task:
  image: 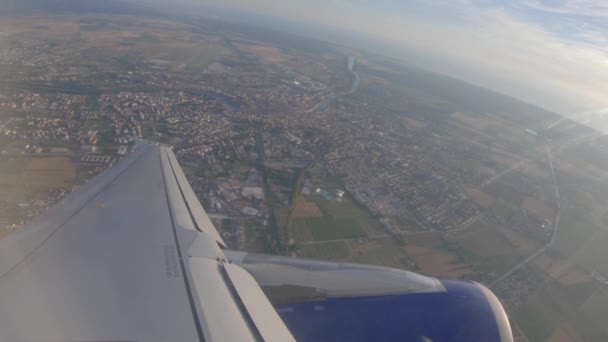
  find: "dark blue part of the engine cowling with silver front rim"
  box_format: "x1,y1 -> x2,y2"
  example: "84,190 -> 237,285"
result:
275,280 -> 513,342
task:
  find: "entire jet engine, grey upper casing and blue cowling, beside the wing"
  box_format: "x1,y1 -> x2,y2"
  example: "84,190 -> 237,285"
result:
226,251 -> 513,342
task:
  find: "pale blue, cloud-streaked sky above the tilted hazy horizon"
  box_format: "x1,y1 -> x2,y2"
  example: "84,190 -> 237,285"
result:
172,0 -> 608,124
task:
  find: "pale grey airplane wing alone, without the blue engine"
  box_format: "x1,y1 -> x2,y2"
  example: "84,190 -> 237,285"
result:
0,144 -> 293,341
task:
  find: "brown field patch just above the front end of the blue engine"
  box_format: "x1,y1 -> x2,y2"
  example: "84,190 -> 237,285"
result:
405,246 -> 473,278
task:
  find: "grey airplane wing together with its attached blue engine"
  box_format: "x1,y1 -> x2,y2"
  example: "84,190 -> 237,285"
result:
0,143 -> 513,341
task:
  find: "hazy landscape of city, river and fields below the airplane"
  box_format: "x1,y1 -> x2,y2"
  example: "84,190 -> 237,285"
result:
0,8 -> 608,341
